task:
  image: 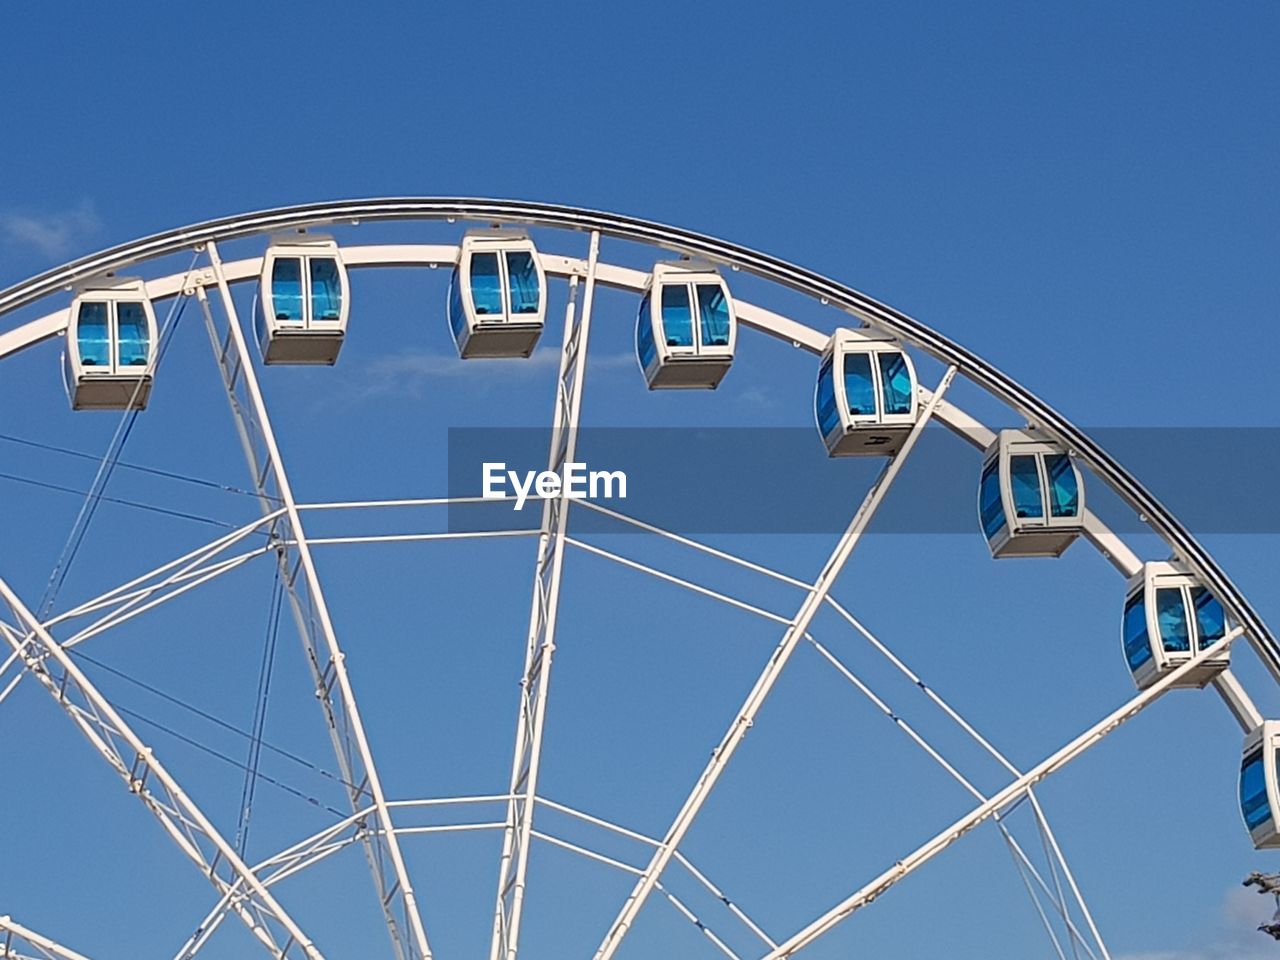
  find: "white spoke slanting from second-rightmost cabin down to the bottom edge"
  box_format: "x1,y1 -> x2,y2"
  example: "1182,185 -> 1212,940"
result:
764,627 -> 1243,960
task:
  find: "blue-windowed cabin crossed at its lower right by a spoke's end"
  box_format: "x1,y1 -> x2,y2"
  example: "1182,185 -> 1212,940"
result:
1121,562 -> 1230,690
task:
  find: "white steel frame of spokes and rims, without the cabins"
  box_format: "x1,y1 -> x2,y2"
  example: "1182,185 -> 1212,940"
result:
0,198 -> 1280,960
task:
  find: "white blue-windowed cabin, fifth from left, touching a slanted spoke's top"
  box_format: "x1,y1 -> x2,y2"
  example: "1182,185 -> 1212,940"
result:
814,328 -> 919,457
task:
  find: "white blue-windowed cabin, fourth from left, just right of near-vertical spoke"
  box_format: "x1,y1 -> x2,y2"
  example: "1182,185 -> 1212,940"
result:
636,261 -> 737,390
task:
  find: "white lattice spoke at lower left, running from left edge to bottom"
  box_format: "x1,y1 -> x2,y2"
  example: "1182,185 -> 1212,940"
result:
0,580 -> 323,960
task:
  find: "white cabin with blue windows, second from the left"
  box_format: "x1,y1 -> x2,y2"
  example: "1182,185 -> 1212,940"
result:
255,237 -> 351,366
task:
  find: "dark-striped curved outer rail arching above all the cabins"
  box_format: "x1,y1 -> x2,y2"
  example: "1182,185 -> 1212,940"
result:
0,197 -> 1280,682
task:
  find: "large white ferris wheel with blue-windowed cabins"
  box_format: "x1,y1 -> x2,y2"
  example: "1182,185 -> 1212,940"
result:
0,197 -> 1280,960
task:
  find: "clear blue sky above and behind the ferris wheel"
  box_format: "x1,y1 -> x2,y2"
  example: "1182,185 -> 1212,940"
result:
0,3 -> 1280,960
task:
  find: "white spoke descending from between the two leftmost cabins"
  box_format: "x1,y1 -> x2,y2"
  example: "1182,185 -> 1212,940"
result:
195,241 -> 431,960
